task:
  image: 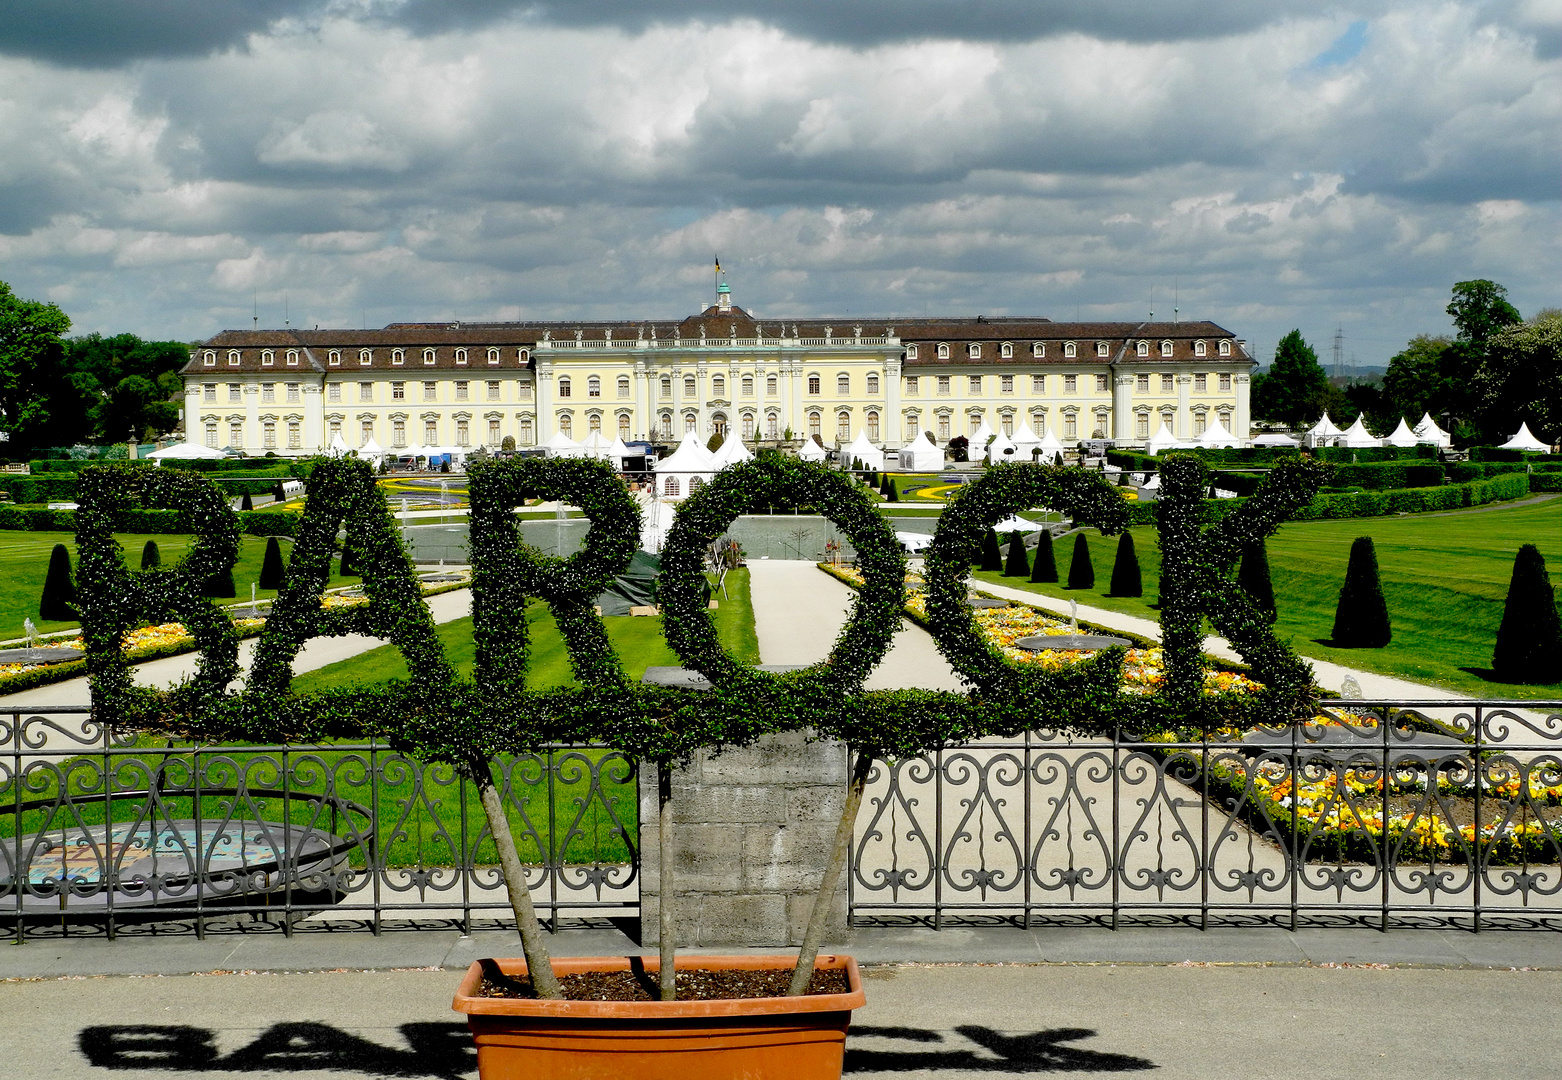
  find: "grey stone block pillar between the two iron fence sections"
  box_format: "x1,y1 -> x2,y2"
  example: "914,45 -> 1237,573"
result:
640,733 -> 848,946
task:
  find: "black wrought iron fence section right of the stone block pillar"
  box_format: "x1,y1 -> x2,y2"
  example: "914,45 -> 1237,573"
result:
848,700 -> 1562,930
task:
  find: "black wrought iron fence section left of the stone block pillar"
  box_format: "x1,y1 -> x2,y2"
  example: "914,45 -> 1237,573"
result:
0,706 -> 639,941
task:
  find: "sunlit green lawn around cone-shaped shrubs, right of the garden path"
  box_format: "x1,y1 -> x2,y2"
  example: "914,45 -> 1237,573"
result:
973,499 -> 1562,699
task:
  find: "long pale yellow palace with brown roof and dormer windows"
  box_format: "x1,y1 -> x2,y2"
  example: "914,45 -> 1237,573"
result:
183,283 -> 1254,456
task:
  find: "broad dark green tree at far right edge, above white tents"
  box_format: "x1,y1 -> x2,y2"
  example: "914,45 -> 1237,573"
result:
1473,308 -> 1562,442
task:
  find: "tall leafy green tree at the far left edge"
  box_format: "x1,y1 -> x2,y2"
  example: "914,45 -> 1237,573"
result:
0,281 -> 73,453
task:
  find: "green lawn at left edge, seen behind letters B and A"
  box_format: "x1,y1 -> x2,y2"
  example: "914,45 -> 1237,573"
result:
0,530 -> 358,639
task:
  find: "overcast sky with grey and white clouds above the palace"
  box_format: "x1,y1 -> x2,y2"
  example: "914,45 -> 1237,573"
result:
0,0 -> 1562,364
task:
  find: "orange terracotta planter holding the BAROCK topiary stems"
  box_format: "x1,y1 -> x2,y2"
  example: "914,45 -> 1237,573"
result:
453,957 -> 867,1080
